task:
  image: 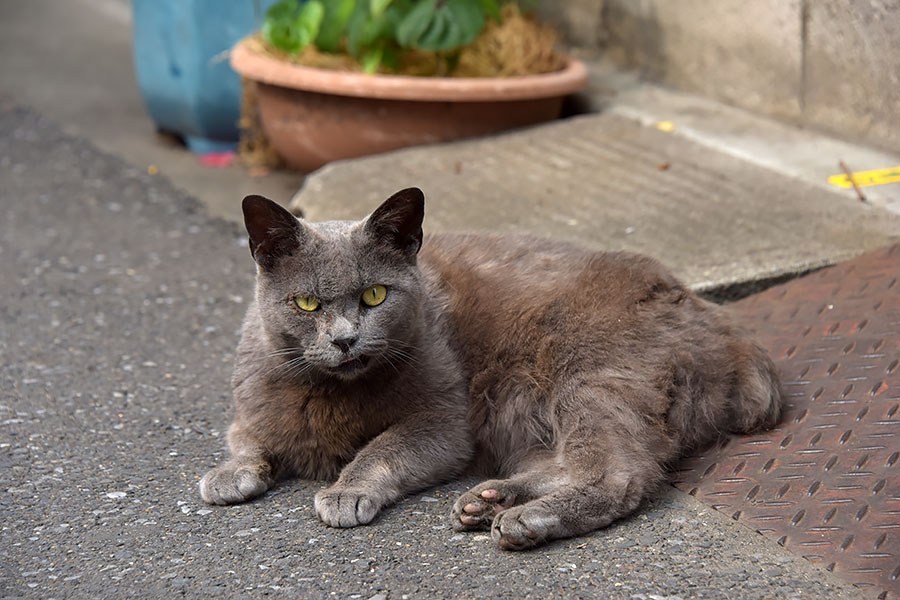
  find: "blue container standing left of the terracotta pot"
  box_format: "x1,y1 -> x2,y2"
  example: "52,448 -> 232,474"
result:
132,0 -> 275,153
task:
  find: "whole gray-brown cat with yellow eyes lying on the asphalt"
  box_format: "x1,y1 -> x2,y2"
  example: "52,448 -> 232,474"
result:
200,188 -> 782,550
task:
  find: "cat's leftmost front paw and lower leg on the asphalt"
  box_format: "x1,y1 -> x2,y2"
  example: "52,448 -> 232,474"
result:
200,425 -> 275,504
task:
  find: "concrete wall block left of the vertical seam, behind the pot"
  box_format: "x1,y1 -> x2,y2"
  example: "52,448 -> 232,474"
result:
605,0 -> 802,120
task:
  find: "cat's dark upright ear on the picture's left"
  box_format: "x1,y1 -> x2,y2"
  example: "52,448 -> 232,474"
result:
241,195 -> 303,269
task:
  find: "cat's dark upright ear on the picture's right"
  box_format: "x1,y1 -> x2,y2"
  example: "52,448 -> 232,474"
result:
366,188 -> 425,256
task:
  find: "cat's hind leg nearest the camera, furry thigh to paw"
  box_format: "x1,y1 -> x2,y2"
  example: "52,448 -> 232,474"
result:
491,420 -> 667,550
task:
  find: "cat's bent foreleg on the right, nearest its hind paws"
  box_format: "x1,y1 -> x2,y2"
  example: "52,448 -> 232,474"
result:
315,414 -> 472,527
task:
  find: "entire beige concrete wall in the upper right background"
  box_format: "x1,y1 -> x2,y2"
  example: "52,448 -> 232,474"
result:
541,0 -> 900,152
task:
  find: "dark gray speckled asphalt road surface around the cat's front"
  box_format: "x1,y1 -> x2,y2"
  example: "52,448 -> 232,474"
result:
0,102 -> 859,600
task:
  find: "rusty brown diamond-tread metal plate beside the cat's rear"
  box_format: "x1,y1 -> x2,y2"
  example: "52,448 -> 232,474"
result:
675,244 -> 900,598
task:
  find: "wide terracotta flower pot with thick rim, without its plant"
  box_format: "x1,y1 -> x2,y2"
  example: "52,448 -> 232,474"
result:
231,42 -> 587,171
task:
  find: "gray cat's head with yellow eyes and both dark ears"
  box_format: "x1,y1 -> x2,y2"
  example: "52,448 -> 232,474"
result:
243,188 -> 425,381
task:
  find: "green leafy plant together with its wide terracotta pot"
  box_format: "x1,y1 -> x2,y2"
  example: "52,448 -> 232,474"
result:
231,0 -> 587,171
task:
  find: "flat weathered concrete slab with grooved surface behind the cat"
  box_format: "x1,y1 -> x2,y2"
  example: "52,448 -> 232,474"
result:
292,109 -> 900,291
